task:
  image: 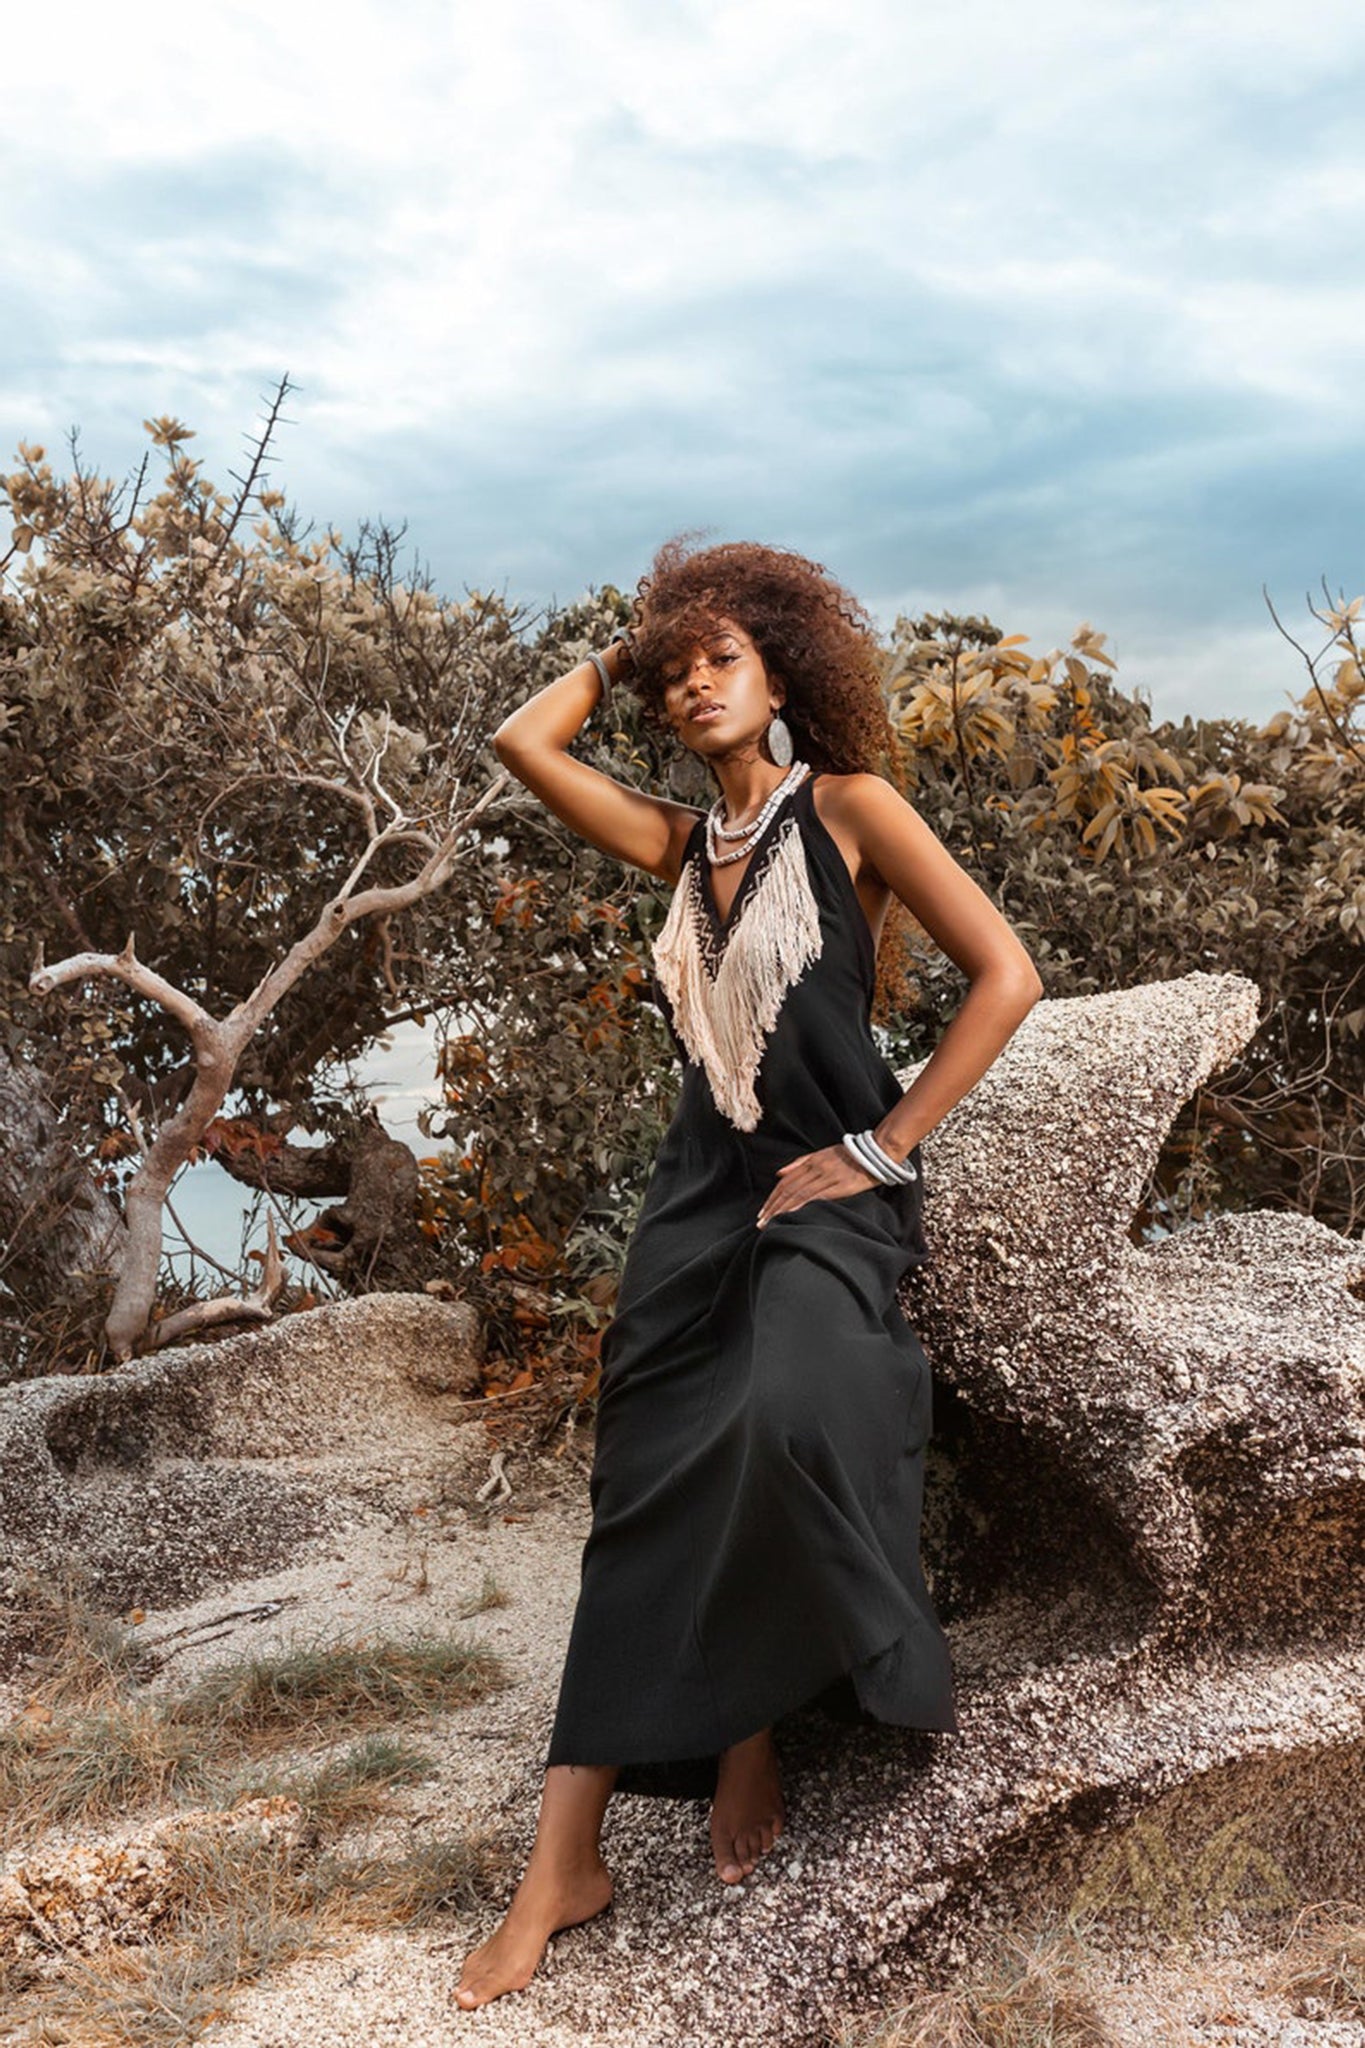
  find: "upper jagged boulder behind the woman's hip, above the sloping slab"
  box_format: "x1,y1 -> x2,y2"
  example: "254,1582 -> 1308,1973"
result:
902,975 -> 1365,1638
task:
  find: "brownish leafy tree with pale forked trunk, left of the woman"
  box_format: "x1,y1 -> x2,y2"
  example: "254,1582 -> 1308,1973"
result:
0,385 -> 526,1358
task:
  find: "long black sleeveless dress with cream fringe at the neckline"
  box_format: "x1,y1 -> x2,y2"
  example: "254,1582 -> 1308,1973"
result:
546,776 -> 958,1794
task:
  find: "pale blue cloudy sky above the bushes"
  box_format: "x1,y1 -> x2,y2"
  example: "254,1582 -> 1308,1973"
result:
0,0 -> 1365,717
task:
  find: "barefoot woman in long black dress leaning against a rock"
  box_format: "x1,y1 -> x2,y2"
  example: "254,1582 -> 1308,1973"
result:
454,543 -> 1042,2009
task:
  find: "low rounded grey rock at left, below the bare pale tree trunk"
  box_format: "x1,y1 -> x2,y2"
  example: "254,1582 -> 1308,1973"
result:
0,1294 -> 479,1613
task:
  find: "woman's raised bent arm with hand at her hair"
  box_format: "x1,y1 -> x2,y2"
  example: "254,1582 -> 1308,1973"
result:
493,641 -> 702,883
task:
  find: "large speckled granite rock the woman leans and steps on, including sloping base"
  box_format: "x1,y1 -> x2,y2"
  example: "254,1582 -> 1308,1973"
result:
464,975 -> 1365,2048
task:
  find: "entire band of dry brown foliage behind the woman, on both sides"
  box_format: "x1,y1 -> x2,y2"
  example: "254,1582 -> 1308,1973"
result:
0,406 -> 1365,1392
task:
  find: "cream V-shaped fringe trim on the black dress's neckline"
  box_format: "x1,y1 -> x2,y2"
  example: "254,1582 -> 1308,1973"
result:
651,817 -> 821,1130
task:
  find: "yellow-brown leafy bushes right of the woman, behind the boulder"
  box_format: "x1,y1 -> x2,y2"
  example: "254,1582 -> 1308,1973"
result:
886,598 -> 1365,1233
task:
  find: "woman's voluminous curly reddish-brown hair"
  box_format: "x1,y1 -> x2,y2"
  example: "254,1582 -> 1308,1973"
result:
630,535 -> 902,784
